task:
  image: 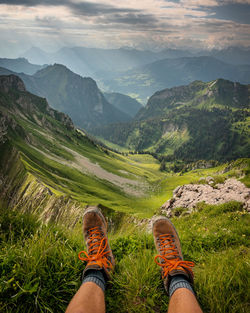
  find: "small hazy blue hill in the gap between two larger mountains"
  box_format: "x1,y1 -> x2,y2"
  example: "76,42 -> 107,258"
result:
103,92 -> 142,117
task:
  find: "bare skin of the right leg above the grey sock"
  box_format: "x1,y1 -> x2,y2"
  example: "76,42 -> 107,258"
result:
168,288 -> 202,313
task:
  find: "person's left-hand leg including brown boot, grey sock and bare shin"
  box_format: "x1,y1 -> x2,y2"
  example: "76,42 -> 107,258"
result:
66,207 -> 115,313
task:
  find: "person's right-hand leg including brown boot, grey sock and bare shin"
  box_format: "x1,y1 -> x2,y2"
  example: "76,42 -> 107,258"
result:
152,217 -> 202,313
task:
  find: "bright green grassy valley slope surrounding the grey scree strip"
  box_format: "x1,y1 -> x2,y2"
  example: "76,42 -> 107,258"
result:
6,100 -> 234,217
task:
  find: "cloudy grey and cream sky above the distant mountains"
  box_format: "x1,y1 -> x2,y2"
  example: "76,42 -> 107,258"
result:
0,0 -> 250,57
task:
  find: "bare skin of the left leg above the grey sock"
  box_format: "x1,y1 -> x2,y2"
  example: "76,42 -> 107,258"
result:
65,282 -> 105,313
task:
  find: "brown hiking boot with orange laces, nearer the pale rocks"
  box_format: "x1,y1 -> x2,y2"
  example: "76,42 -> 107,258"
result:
152,216 -> 194,292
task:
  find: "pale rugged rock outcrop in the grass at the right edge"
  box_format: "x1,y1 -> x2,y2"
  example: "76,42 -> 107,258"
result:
161,177 -> 250,217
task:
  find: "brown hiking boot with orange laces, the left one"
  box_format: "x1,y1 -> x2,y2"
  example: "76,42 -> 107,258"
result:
78,207 -> 115,280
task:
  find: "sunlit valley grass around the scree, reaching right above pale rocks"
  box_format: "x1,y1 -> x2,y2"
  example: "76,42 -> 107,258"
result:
4,134 -> 249,218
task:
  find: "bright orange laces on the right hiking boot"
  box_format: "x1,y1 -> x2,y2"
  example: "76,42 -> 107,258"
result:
155,234 -> 194,278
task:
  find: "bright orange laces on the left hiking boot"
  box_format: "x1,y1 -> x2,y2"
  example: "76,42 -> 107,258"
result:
78,227 -> 112,269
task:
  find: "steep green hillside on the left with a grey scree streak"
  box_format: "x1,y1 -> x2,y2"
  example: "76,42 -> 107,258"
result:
0,75 -> 173,221
